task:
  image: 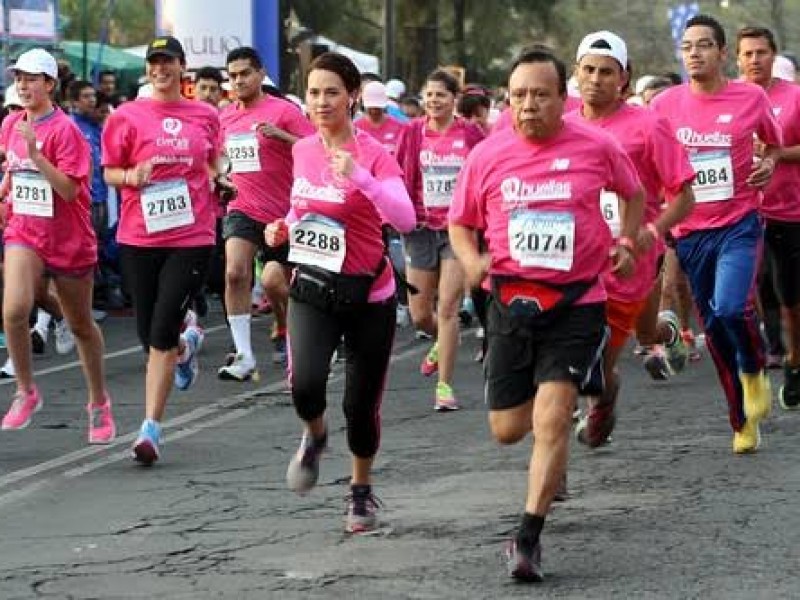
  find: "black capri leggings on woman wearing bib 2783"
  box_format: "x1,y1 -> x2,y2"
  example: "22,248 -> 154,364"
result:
120,246 -> 214,351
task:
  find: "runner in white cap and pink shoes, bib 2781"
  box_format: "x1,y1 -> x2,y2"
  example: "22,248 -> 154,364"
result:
0,48 -> 116,444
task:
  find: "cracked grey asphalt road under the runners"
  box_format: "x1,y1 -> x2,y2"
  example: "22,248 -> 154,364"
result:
0,308 -> 800,600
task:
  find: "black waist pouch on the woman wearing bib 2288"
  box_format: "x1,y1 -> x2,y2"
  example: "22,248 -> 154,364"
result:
289,265 -> 377,312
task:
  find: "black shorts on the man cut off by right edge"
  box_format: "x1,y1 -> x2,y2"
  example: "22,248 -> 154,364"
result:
764,219 -> 800,307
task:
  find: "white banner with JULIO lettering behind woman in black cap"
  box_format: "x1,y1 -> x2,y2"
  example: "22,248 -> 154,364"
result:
156,0 -> 253,69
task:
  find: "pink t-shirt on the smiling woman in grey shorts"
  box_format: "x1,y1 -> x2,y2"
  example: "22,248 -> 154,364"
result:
409,119 -> 472,231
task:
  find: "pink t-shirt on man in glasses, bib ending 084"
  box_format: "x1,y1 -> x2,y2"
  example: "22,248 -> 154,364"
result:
650,81 -> 781,237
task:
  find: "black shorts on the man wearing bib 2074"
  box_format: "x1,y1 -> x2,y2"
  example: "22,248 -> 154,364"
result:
484,298 -> 606,410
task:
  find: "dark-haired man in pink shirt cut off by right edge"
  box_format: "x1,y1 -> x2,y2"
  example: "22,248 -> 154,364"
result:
736,27 -> 800,410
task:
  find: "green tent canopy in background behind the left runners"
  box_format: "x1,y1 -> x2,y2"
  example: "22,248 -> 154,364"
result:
56,41 -> 144,95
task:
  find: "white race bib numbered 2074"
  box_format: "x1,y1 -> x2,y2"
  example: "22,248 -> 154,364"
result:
508,210 -> 575,271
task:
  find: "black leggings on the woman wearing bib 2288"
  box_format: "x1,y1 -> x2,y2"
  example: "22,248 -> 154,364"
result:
287,298 -> 396,458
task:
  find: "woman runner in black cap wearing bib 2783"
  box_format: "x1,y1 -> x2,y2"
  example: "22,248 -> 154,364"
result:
103,37 -> 219,465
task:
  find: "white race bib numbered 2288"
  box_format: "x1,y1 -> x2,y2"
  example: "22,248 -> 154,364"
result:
289,214 -> 347,273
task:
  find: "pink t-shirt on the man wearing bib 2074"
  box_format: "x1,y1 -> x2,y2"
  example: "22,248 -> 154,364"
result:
450,121 -> 640,304
